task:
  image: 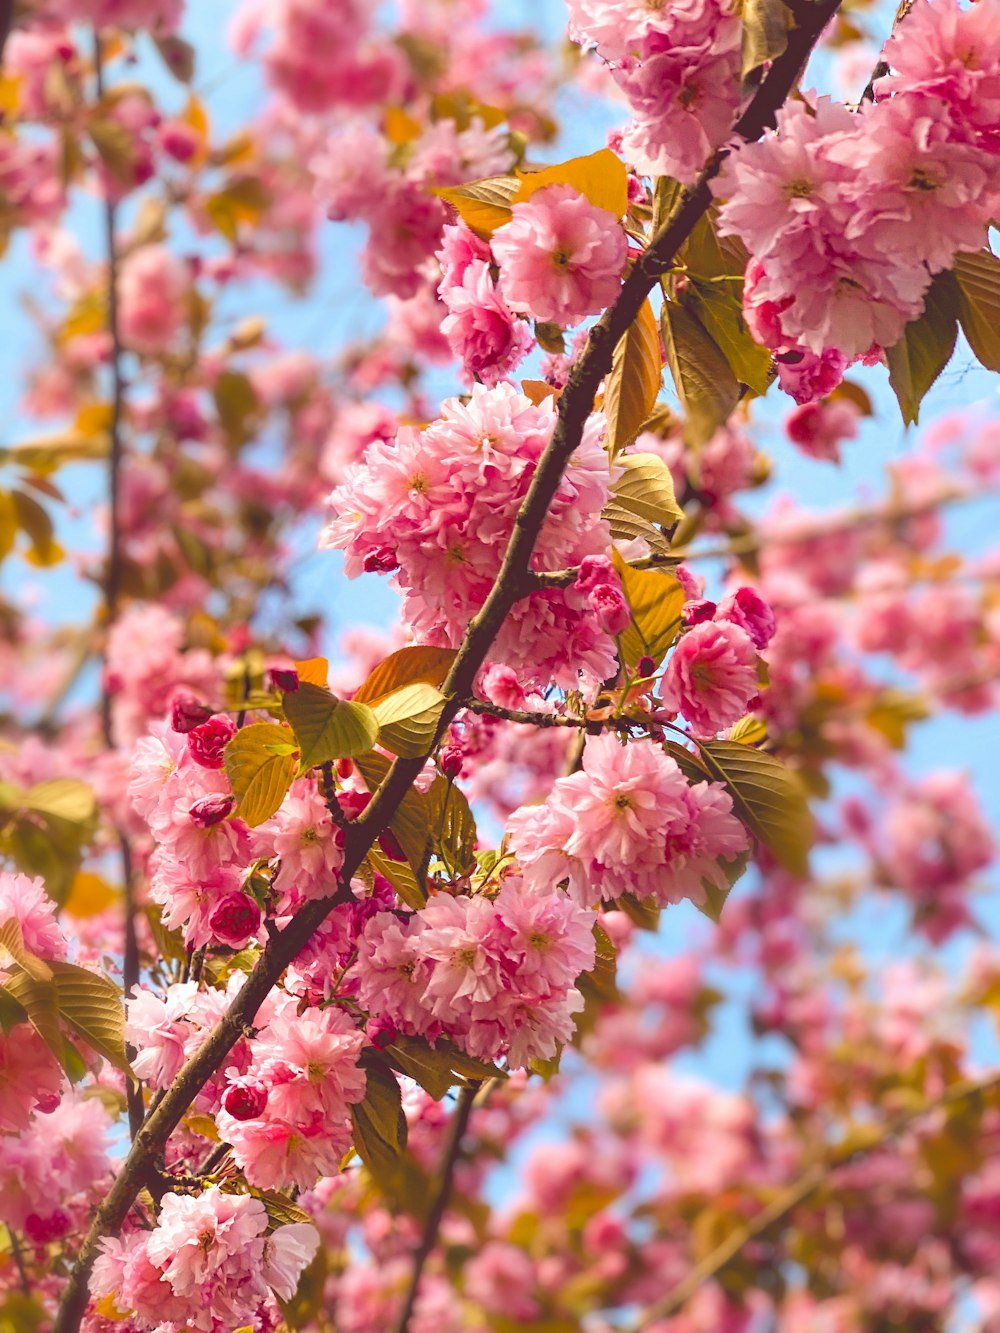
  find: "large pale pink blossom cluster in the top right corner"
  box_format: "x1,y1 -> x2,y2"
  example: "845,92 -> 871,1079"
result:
713,0 -> 1000,381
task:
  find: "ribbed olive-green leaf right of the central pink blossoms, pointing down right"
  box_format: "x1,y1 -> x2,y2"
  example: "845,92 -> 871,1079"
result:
699,741 -> 813,877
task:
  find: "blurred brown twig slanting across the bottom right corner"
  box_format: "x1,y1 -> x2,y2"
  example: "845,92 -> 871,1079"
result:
627,1072 -> 1000,1333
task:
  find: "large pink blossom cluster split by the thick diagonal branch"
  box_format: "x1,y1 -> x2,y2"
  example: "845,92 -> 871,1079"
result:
323,383 -> 615,688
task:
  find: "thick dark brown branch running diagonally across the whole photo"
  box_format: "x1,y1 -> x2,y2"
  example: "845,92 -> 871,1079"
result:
53,0 -> 840,1333
